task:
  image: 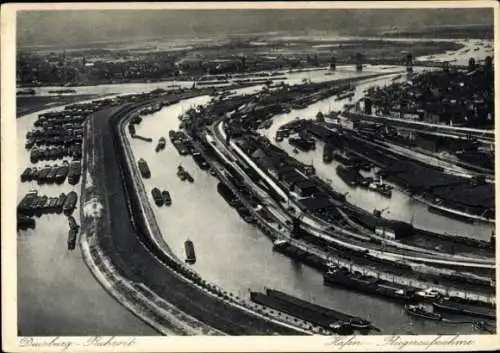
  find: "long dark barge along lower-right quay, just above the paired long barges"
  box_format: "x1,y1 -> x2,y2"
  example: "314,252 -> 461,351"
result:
323,267 -> 414,302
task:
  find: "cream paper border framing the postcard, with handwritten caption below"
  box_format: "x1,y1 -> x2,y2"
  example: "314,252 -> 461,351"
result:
0,1 -> 500,352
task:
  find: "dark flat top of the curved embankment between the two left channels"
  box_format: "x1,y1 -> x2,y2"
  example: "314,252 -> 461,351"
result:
85,97 -> 297,335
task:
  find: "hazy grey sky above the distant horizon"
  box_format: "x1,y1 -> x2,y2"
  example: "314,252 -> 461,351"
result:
17,9 -> 493,47
